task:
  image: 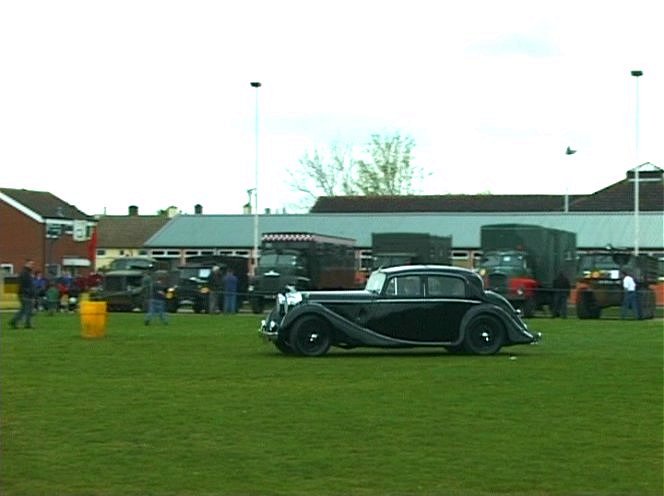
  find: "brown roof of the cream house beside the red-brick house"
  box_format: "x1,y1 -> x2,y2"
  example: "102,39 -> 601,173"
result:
97,215 -> 170,248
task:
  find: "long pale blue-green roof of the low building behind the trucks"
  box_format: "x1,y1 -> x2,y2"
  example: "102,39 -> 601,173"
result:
148,212 -> 664,254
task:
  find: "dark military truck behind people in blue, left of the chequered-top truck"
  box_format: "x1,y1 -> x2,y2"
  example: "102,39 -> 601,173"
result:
166,255 -> 249,313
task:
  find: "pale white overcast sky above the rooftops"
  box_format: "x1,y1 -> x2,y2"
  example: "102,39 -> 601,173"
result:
0,0 -> 664,215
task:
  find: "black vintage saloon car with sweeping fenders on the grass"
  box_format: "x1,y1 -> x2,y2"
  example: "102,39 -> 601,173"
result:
260,265 -> 540,356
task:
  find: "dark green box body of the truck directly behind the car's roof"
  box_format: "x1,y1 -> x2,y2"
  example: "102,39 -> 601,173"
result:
371,232 -> 452,269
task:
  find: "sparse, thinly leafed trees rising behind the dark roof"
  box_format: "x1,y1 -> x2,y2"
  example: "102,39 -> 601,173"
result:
291,133 -> 422,207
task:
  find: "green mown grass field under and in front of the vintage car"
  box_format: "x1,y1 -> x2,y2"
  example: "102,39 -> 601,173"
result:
0,313 -> 664,496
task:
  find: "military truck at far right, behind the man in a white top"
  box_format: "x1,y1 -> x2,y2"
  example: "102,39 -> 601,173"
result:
575,248 -> 659,319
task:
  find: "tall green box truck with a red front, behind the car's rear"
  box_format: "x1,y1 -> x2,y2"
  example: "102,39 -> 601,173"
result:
479,224 -> 576,317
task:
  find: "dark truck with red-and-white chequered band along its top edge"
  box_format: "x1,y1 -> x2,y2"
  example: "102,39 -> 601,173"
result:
249,232 -> 355,313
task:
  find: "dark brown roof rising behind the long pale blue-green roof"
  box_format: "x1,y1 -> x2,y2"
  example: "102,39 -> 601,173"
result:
311,162 -> 664,213
